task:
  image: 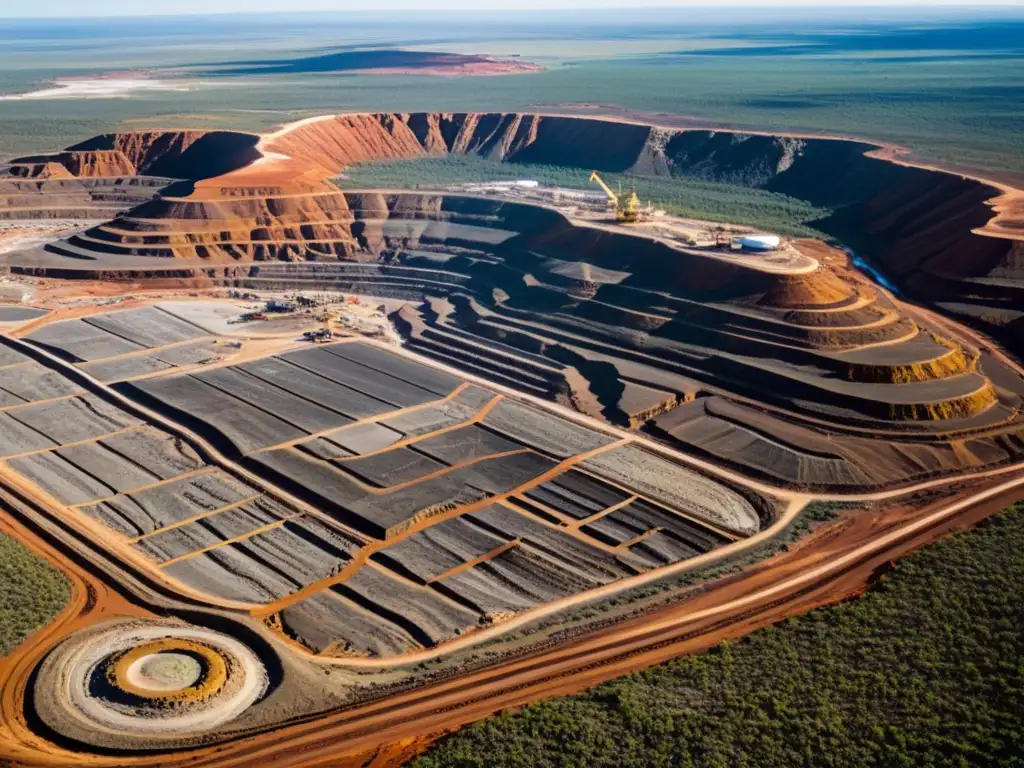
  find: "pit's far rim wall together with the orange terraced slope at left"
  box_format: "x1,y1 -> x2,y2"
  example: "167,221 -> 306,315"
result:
0,113 -> 1024,352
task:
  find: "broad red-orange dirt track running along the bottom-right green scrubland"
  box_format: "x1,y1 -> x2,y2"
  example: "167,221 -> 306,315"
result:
0,473 -> 1022,768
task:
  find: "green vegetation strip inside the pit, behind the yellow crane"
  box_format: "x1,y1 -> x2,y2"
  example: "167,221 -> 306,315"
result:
340,155 -> 830,237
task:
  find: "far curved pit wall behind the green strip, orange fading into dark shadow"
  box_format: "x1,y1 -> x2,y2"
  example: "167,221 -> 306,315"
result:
284,113 -> 1024,352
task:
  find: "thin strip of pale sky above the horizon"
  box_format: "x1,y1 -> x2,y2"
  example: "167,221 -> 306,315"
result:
0,0 -> 1024,18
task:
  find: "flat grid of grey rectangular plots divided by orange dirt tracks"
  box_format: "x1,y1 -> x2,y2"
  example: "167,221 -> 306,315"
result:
0,325 -> 774,654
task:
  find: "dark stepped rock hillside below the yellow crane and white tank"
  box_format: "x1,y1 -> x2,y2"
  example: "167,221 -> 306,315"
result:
323,193 -> 1018,428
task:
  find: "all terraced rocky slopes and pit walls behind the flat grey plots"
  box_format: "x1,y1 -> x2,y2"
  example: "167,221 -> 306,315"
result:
0,114 -> 1024,487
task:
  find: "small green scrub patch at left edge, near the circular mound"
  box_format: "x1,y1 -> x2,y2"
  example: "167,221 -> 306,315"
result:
0,534 -> 71,656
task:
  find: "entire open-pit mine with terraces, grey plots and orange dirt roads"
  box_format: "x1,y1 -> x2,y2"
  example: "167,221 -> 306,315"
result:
0,114 -> 1024,766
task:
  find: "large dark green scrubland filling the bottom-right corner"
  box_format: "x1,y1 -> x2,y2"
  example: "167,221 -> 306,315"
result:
413,505 -> 1024,768
